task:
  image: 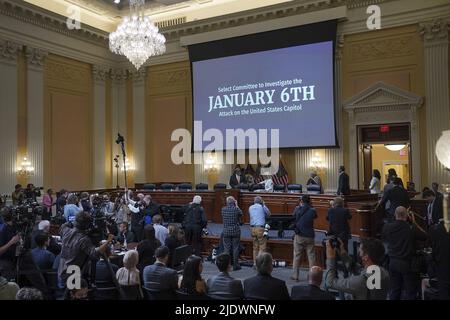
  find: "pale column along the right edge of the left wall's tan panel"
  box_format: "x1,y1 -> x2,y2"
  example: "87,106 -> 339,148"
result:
92,65 -> 109,189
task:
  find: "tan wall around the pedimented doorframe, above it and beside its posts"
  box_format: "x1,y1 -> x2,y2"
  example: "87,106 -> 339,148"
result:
342,25 -> 427,185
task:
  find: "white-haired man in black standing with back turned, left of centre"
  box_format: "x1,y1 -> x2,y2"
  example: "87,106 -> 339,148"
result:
183,195 -> 208,257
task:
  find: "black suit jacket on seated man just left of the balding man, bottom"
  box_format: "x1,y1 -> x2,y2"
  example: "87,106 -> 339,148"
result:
244,274 -> 289,300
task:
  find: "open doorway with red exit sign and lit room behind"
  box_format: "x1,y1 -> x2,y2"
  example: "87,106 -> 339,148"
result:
358,123 -> 412,190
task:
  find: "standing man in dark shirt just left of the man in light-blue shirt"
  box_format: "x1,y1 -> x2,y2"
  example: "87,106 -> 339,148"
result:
222,196 -> 242,271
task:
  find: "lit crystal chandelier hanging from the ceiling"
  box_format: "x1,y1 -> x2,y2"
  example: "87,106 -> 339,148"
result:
109,0 -> 166,70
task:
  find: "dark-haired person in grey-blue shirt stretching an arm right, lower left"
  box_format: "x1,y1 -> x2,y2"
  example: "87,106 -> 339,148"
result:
58,212 -> 113,286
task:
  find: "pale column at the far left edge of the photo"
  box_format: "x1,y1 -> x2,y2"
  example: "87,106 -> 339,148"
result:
0,39 -> 22,195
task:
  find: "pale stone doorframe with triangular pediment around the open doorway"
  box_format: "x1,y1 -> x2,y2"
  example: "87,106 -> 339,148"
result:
343,82 -> 423,189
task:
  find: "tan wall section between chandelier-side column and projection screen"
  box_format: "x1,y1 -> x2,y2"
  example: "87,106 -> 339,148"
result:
146,61 -> 194,182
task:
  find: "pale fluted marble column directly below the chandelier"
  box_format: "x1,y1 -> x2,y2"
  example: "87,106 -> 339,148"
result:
133,68 -> 147,183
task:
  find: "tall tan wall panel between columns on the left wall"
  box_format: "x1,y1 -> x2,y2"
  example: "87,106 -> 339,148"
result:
44,55 -> 93,190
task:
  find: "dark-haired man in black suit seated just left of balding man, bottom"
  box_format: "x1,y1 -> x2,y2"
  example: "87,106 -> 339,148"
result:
244,252 -> 290,300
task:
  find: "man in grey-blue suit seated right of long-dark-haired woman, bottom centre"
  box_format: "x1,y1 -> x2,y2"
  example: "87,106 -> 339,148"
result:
207,253 -> 244,300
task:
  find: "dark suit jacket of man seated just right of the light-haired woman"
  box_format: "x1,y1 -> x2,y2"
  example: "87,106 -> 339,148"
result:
143,262 -> 178,295
